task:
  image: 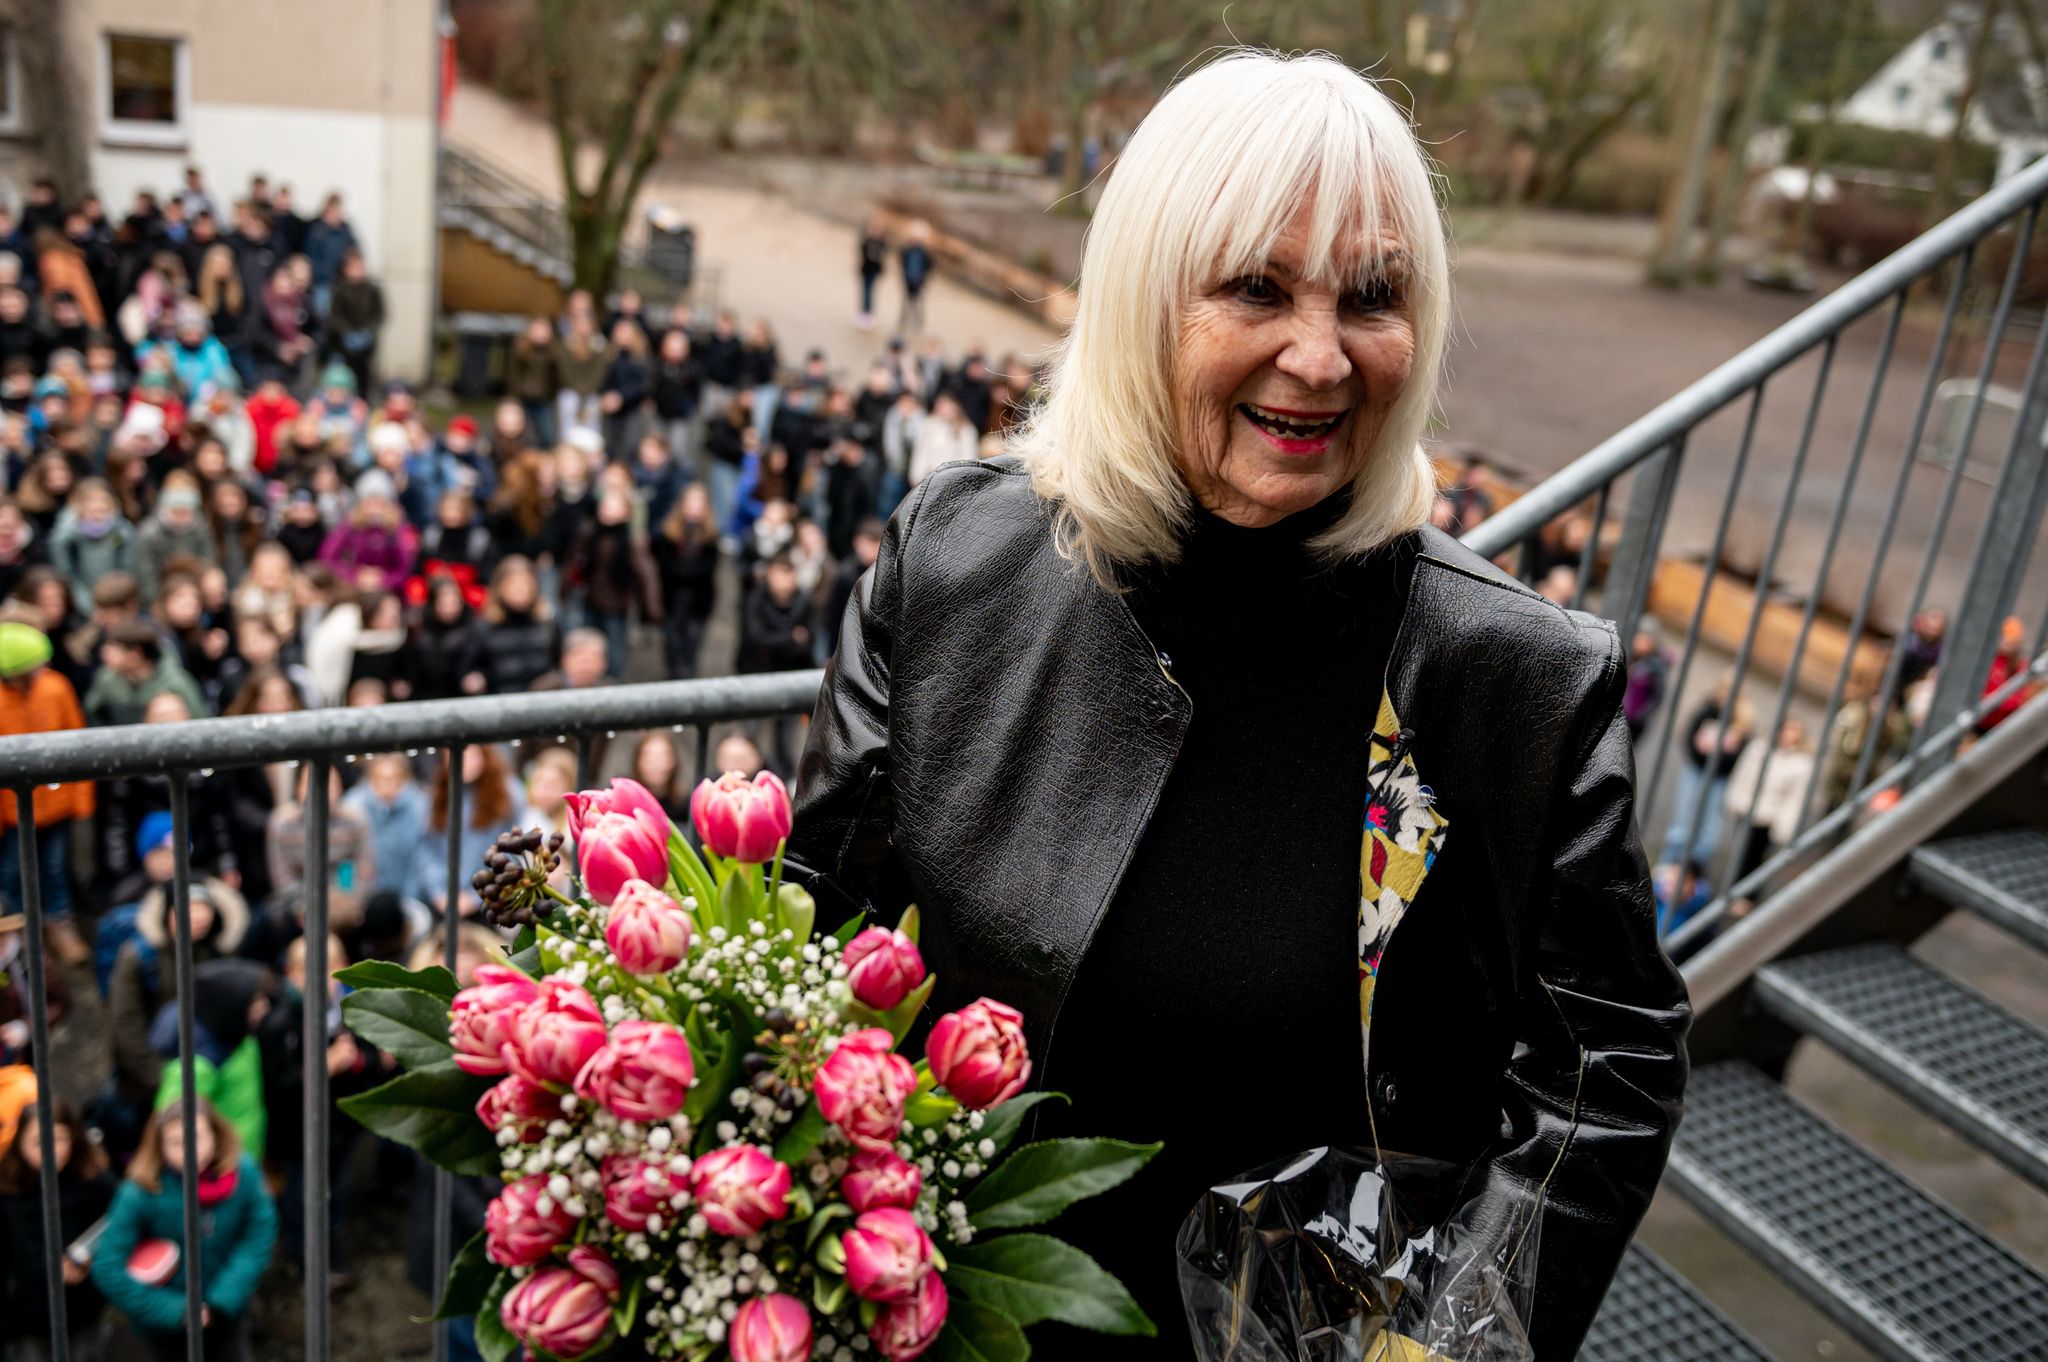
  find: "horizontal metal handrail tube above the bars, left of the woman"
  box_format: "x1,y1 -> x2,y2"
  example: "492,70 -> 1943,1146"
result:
0,670 -> 825,786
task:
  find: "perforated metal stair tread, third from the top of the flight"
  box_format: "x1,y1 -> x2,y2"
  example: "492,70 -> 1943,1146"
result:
1665,1061 -> 2048,1362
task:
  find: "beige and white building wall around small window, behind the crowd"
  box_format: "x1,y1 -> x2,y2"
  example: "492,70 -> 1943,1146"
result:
17,0 -> 438,379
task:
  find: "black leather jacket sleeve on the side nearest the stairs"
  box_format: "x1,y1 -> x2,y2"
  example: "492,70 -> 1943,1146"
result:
1485,633 -> 1692,1360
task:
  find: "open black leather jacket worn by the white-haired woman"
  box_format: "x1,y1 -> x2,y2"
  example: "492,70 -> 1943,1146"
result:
791,459 -> 1690,1362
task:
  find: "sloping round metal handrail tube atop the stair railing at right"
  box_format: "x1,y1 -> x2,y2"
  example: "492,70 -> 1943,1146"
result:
1464,158 -> 2048,557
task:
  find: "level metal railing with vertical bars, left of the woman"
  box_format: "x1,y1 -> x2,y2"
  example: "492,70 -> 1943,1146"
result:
0,670 -> 823,1362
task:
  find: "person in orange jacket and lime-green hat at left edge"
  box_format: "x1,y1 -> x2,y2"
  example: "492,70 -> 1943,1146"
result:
0,621 -> 92,965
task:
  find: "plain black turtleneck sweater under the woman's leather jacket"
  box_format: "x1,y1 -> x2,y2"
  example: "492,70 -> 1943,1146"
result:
1034,494 -> 1407,1362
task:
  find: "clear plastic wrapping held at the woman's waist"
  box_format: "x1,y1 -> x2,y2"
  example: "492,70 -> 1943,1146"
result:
1176,1149 -> 1540,1362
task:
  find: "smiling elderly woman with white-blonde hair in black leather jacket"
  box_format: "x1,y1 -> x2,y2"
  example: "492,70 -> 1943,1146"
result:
793,53 -> 1690,1362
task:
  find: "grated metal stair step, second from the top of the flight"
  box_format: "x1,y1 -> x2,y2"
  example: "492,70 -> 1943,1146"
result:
1757,942 -> 2048,1188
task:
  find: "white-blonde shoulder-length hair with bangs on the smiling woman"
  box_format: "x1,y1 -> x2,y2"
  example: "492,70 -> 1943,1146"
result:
1010,49 -> 1450,590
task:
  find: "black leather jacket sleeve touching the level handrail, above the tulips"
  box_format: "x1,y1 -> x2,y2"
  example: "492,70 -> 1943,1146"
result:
786,477 -> 926,926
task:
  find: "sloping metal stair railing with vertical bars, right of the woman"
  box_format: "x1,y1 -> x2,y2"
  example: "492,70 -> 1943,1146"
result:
1466,160 -> 2048,959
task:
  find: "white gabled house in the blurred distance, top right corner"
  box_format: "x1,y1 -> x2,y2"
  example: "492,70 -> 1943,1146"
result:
1841,4 -> 2048,180
